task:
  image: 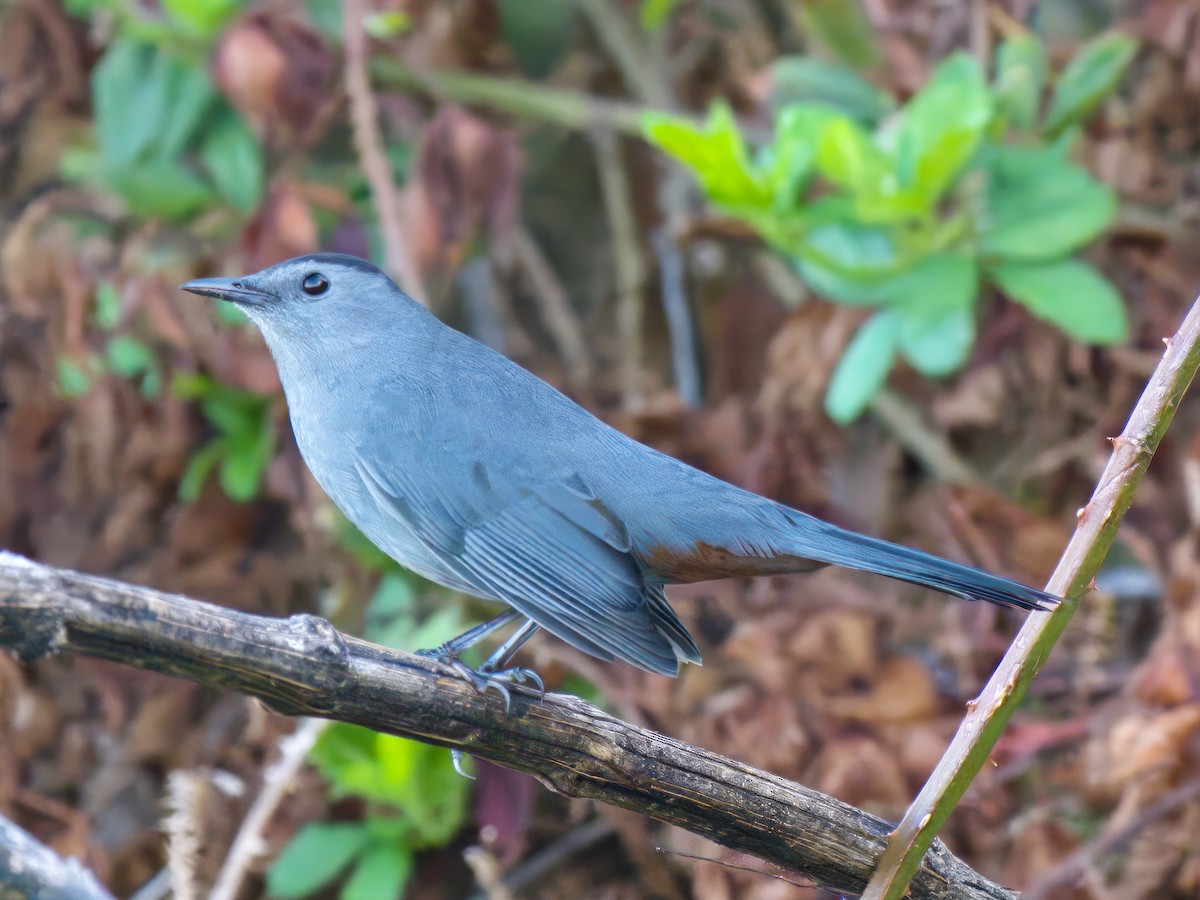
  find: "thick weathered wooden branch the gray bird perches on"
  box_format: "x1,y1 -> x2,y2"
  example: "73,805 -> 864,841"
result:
0,552 -> 1015,899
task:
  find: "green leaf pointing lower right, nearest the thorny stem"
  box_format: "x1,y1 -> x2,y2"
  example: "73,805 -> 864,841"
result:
988,259 -> 1129,344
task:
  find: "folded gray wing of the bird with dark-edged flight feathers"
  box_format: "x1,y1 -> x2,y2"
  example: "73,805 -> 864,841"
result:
350,463 -> 700,674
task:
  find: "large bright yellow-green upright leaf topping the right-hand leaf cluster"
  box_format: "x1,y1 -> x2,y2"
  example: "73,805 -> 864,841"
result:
881,53 -> 992,209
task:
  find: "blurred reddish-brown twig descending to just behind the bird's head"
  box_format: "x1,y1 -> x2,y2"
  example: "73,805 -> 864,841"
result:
342,0 -> 425,304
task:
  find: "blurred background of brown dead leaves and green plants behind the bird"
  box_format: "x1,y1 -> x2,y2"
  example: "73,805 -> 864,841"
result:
0,0 -> 1200,900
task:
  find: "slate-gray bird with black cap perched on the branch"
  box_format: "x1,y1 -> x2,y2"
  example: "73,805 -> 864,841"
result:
182,253 -> 1058,689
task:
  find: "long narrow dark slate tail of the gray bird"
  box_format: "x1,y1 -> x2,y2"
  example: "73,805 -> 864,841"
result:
798,516 -> 1062,610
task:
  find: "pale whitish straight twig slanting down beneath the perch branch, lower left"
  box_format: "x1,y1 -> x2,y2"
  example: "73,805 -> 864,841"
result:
209,719 -> 332,900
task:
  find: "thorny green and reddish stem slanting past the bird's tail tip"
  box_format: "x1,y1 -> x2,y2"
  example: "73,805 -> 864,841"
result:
863,299 -> 1200,900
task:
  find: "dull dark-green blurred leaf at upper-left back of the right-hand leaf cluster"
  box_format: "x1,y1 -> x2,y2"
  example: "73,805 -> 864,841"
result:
768,56 -> 896,126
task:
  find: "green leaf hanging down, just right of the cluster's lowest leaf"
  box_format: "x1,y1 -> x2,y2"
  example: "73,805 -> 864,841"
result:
888,253 -> 979,378
